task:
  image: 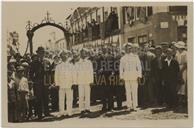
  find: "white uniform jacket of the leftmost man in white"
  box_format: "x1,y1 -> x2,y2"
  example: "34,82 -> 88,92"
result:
55,61 -> 72,88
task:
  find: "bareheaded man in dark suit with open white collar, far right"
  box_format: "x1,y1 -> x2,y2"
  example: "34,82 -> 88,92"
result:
162,48 -> 180,108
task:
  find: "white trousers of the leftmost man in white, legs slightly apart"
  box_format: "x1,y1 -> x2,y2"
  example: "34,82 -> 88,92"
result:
59,88 -> 73,115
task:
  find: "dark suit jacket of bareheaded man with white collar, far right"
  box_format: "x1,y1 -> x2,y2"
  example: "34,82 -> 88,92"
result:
162,59 -> 180,85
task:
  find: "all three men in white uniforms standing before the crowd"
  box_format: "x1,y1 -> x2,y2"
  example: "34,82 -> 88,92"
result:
55,43 -> 142,116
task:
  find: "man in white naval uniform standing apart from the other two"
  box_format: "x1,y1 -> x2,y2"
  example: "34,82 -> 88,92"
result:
119,43 -> 142,110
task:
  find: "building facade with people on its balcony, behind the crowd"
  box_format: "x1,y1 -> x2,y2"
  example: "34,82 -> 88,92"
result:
67,6 -> 187,48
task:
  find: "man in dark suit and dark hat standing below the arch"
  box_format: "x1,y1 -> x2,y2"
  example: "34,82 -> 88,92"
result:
29,47 -> 50,119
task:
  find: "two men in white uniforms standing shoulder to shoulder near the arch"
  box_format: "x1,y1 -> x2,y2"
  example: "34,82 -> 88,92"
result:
55,48 -> 94,116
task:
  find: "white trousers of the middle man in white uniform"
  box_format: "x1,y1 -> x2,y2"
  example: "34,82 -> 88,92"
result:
79,85 -> 90,111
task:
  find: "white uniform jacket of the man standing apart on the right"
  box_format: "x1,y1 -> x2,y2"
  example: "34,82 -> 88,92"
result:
119,53 -> 142,81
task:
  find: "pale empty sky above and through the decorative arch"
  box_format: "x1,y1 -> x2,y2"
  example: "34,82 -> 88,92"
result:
2,2 -> 76,54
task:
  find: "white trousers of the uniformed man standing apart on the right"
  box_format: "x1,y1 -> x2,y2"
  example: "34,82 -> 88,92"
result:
125,80 -> 138,109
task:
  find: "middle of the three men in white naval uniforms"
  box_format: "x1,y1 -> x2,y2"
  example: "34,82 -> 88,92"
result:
77,48 -> 94,114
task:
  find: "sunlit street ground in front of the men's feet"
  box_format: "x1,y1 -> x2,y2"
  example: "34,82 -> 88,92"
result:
32,103 -> 188,122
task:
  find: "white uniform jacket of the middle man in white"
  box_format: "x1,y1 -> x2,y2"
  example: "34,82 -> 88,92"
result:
77,59 -> 94,85
